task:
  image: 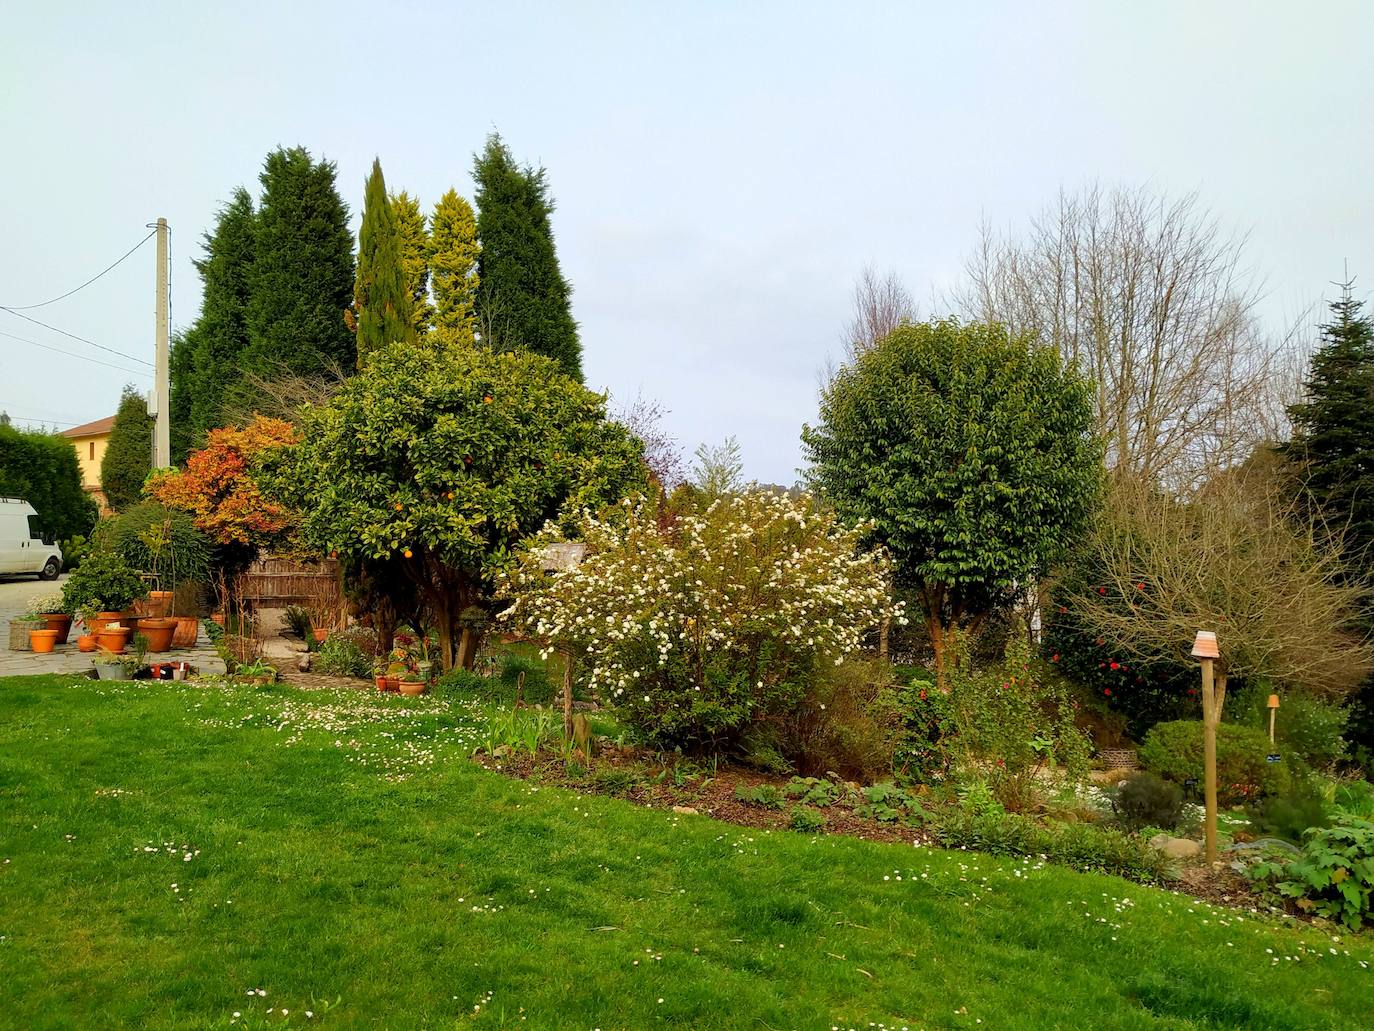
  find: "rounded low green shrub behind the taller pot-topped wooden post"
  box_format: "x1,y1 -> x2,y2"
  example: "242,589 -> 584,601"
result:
1139,720 -> 1292,806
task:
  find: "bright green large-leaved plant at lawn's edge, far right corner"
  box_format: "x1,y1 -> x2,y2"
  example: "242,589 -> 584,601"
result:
1250,819 -> 1374,931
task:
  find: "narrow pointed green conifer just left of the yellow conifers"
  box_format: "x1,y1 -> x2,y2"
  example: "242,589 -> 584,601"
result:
353,158 -> 415,368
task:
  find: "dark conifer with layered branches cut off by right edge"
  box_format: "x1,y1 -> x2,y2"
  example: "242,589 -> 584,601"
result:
1283,283 -> 1374,566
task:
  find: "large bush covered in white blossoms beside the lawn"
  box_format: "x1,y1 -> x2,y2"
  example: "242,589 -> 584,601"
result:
503,491 -> 900,748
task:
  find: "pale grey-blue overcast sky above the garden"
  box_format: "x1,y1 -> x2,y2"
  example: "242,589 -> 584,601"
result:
0,0 -> 1374,484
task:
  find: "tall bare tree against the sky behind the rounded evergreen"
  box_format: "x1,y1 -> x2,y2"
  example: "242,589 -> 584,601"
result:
956,188 -> 1279,485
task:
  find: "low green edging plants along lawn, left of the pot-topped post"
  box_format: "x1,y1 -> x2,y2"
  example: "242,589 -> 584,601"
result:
934,810 -> 1169,884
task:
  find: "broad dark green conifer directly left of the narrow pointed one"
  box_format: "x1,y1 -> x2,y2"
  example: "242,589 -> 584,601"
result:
242,147 -> 357,375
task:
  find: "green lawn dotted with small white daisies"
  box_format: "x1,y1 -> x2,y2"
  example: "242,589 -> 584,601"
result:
0,678 -> 1374,1031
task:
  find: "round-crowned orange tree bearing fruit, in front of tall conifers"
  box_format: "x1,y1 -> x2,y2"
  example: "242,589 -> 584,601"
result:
269,338 -> 647,669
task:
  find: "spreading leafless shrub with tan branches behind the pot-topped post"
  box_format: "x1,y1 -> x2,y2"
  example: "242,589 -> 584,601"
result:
1076,463 -> 1374,694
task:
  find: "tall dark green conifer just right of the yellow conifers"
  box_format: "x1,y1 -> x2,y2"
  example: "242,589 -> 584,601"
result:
473,133 -> 583,379
